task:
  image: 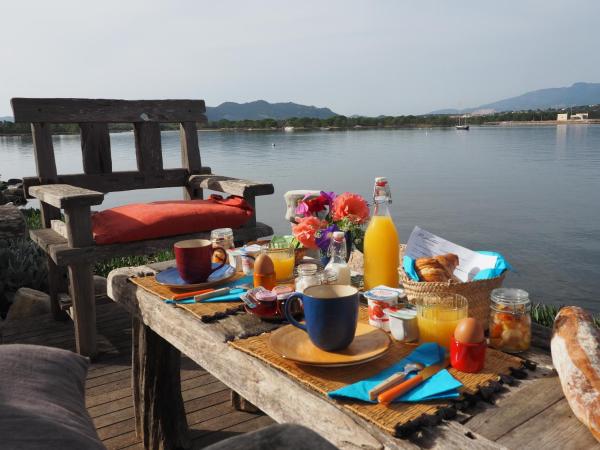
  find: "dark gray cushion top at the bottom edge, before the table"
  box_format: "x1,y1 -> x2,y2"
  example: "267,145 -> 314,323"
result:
205,424 -> 337,450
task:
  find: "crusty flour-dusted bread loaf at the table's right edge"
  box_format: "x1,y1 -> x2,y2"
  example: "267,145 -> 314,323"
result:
550,306 -> 600,442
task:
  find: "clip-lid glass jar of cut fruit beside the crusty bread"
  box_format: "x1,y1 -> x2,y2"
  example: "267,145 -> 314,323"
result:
490,288 -> 531,353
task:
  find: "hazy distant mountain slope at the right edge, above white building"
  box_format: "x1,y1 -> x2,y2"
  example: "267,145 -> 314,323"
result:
431,82 -> 600,114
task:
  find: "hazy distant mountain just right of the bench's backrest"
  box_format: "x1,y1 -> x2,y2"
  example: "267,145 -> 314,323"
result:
206,100 -> 337,122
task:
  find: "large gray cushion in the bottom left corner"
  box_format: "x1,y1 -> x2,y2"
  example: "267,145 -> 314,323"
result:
0,344 -> 105,449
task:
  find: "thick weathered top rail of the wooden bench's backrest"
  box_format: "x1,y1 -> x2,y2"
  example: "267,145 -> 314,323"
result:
11,98 -> 206,123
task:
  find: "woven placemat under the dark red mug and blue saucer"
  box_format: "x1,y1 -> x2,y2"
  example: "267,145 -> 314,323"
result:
130,273 -> 244,322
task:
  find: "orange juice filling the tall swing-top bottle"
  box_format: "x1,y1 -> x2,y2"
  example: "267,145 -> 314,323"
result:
364,216 -> 400,290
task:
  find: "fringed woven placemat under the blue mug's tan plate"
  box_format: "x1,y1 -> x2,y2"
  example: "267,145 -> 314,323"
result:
230,306 -> 522,434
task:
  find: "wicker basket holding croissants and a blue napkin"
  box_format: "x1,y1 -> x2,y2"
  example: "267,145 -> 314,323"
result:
400,246 -> 505,329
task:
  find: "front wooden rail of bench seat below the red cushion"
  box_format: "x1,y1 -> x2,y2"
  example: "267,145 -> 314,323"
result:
29,222 -> 273,266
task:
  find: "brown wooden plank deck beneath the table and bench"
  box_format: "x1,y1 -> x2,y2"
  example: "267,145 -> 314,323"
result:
2,301 -> 273,449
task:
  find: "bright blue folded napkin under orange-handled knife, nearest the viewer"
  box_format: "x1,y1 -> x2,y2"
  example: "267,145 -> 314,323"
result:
328,342 -> 462,403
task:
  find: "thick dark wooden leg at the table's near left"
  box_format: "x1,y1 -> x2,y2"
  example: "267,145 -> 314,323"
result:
131,318 -> 191,449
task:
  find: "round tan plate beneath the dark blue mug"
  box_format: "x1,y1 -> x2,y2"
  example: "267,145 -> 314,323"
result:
269,322 -> 391,367
